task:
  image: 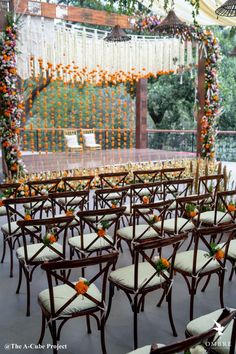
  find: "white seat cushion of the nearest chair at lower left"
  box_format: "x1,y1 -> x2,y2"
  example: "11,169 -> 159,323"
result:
38,284 -> 101,315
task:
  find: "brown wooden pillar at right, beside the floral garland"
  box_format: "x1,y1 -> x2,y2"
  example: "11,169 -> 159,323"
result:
197,49 -> 205,157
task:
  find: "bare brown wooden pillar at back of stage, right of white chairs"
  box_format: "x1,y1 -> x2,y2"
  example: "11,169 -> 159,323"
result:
136,79 -> 148,149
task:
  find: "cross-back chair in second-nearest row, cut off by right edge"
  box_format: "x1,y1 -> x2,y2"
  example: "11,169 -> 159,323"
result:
200,190 -> 236,226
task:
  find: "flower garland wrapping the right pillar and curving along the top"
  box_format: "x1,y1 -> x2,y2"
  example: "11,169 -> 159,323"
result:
135,16 -> 221,159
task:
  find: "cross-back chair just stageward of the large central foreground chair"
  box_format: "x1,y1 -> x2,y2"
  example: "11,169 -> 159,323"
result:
117,200 -> 173,257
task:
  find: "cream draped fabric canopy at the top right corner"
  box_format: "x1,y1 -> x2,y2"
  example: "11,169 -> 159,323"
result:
142,0 -> 236,26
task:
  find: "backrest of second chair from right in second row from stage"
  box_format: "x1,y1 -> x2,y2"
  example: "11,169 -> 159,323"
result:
163,178 -> 194,200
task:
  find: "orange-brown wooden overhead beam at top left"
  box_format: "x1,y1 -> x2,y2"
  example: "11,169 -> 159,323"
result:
15,0 -> 130,28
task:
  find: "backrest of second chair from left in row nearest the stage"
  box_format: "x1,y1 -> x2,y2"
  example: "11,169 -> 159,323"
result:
27,178 -> 61,196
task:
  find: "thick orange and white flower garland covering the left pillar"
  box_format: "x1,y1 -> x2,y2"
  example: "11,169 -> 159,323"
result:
0,15 -> 25,176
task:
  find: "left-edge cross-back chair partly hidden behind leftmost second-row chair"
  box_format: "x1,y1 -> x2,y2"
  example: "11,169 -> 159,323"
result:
1,196 -> 48,277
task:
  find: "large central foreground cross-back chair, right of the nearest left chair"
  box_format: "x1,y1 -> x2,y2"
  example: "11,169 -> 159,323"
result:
108,234 -> 187,348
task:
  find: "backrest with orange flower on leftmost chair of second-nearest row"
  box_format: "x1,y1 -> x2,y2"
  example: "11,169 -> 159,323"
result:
17,216 -> 73,264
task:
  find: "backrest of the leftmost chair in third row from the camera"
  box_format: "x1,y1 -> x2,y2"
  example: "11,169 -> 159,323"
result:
4,196 -> 48,234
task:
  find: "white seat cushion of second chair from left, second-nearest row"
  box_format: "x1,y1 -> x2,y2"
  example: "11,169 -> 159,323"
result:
68,233 -> 113,251
